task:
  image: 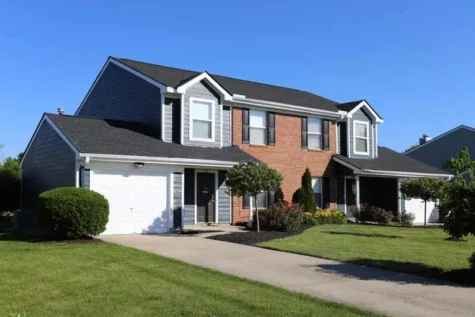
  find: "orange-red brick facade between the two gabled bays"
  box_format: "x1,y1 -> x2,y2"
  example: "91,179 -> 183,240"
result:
232,108 -> 336,223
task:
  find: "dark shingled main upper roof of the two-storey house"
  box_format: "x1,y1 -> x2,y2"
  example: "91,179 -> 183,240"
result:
111,57 -> 338,112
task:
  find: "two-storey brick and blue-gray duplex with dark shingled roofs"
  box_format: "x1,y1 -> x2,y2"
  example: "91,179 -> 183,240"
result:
17,57 -> 449,233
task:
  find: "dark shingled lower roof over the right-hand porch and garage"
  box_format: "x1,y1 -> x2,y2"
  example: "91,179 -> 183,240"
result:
334,146 -> 450,176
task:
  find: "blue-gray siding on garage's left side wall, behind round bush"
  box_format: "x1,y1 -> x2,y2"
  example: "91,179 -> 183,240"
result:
22,120 -> 76,210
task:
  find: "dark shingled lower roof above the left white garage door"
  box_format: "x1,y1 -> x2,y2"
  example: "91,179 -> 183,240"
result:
46,113 -> 257,162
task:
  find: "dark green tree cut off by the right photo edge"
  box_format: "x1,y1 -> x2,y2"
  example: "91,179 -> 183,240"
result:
442,147 -> 475,240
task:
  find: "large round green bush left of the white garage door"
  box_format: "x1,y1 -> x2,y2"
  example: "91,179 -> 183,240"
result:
37,187 -> 109,239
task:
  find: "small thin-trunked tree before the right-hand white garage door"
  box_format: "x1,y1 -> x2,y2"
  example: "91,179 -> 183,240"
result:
401,178 -> 444,226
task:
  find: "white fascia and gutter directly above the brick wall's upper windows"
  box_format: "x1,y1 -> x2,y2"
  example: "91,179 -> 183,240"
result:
233,97 -> 342,120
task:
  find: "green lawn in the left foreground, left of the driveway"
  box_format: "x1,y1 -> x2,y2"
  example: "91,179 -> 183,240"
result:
0,235 -> 377,317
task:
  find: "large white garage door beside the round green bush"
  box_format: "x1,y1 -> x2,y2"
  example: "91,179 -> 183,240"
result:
91,170 -> 169,234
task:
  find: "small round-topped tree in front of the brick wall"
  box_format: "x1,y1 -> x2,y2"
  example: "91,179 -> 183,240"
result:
226,162 -> 282,232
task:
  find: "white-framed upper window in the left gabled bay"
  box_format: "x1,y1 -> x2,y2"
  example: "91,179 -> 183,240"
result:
190,98 -> 214,142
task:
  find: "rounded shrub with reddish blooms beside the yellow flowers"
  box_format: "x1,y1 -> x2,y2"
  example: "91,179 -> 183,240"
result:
254,200 -> 303,231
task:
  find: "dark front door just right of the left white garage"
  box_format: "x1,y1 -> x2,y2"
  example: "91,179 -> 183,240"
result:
196,172 -> 216,222
